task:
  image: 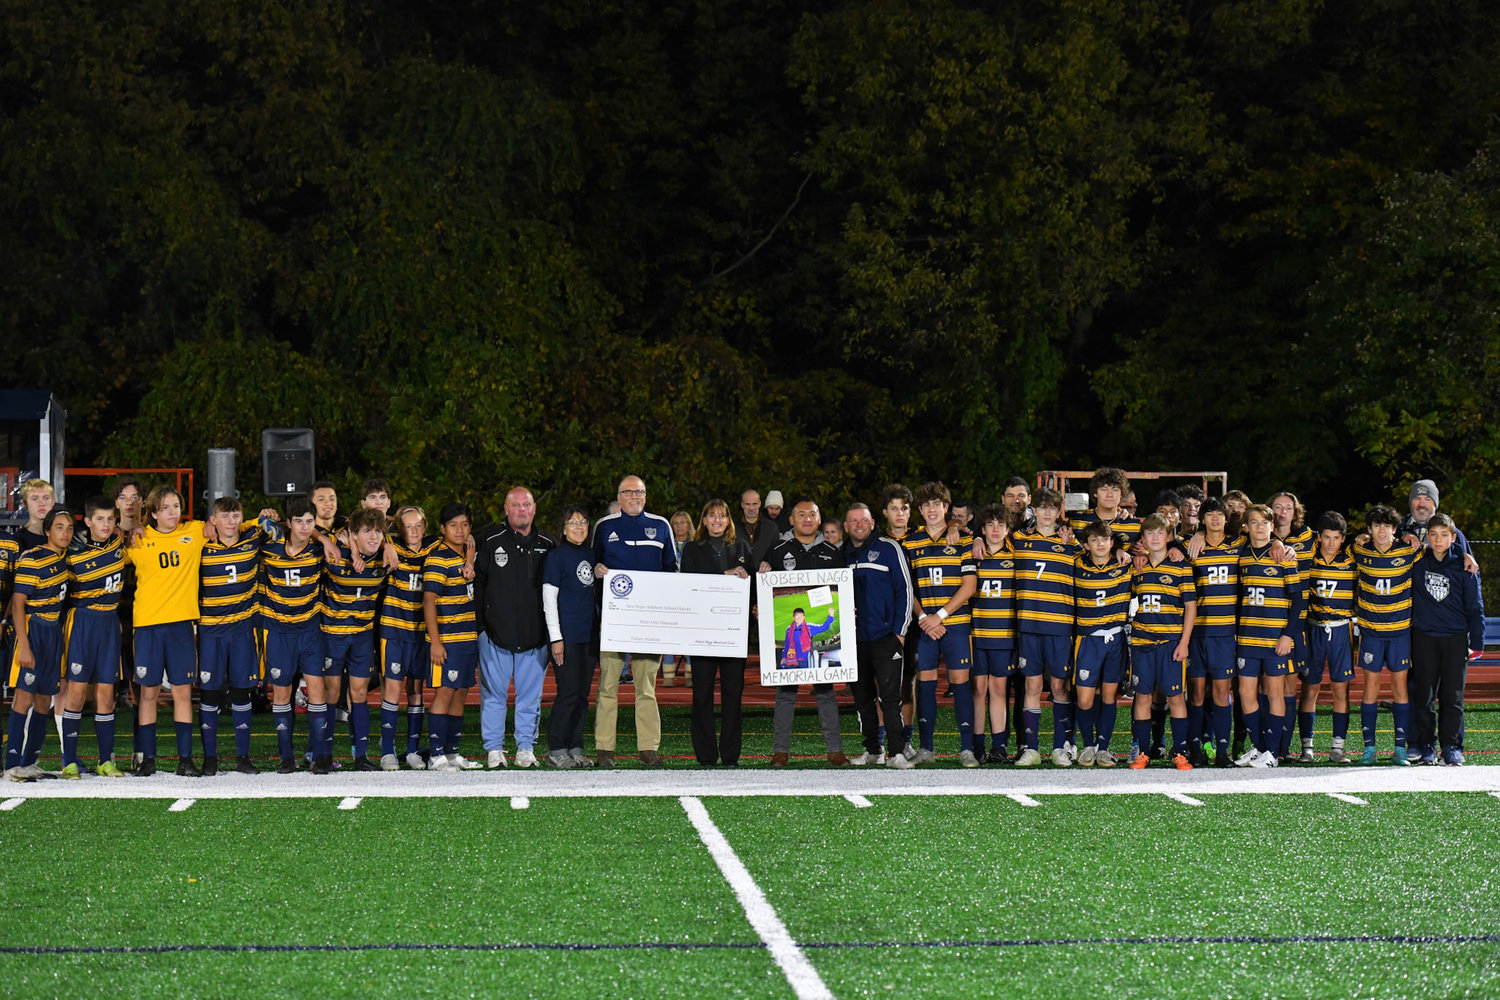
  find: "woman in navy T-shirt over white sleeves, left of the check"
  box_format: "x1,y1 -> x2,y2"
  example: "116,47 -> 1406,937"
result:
542,505 -> 599,768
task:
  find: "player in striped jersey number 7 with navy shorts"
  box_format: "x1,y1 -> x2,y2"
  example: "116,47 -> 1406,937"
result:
1011,489 -> 1079,768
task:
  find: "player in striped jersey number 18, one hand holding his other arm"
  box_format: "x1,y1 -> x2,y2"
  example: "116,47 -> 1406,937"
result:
902,481 -> 980,768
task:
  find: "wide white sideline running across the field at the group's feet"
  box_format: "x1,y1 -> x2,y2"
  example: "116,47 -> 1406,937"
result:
5,766 -> 1500,801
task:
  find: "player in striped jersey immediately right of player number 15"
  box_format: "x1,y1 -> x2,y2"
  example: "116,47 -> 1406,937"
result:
321,507 -> 387,771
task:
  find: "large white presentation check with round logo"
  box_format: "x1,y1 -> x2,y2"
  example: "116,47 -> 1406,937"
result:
599,570 -> 750,657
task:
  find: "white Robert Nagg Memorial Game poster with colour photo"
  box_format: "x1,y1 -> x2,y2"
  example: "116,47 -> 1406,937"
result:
758,568 -> 860,687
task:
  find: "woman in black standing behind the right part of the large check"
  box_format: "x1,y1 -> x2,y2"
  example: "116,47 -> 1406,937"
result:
683,498 -> 750,768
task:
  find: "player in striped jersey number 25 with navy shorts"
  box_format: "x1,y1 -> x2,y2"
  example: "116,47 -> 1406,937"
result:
1130,514 -> 1197,771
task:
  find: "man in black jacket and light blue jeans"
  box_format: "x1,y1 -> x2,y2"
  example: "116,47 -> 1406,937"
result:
474,486 -> 557,768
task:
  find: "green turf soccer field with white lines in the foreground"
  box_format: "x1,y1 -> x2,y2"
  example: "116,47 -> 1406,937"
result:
0,711 -> 1500,997
